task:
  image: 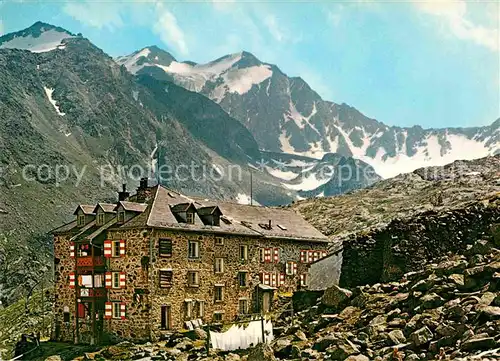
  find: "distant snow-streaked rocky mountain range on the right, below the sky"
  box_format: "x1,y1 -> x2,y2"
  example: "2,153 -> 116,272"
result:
117,47 -> 500,178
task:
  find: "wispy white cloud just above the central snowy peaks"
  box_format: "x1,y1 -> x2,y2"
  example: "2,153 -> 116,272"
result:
153,3 -> 189,55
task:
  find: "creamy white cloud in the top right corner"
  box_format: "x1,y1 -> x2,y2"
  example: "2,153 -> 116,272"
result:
414,0 -> 500,51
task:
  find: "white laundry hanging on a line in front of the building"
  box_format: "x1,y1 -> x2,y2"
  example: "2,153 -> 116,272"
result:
210,320 -> 274,351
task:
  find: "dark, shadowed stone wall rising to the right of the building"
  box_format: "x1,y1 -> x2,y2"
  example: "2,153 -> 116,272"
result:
339,198 -> 500,288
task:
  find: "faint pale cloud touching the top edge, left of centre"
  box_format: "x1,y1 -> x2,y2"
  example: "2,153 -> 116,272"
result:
63,1 -> 123,30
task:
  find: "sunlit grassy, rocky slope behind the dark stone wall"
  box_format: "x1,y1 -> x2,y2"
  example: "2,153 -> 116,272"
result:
292,155 -> 500,239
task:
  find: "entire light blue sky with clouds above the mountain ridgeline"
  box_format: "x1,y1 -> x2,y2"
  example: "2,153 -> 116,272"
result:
0,0 -> 500,128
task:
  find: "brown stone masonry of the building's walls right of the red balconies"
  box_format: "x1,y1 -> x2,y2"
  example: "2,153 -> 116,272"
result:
105,229 -> 327,339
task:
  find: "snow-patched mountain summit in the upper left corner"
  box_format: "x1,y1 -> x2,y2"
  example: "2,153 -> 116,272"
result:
0,21 -> 74,53
